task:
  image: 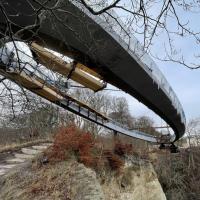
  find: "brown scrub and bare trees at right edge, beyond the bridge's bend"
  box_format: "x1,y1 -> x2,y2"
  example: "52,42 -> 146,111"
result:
152,118 -> 200,200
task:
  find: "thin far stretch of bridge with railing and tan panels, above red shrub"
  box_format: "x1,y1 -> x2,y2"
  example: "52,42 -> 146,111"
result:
0,62 -> 158,143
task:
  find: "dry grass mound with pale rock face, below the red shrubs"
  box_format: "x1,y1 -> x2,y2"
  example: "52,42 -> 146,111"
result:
0,157 -> 166,200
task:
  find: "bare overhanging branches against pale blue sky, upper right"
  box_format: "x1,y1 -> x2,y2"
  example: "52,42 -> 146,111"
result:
78,0 -> 200,69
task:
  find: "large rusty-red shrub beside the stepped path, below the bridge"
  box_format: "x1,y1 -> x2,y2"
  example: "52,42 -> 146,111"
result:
48,125 -> 96,166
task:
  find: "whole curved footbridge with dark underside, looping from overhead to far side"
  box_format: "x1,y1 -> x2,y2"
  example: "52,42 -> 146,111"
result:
0,0 -> 186,142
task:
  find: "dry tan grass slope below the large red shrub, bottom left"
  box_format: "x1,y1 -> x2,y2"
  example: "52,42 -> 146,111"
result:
0,157 -> 102,200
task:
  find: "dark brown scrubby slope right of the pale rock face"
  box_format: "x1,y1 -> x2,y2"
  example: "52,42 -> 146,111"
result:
153,147 -> 200,200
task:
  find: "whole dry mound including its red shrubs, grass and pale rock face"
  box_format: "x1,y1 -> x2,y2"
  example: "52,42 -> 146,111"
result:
0,126 -> 166,200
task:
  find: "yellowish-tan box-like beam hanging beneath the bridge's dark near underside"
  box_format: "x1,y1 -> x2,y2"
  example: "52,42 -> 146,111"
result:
31,42 -> 106,91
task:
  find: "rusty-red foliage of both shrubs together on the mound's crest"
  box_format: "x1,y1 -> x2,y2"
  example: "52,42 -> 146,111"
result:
46,125 -> 125,171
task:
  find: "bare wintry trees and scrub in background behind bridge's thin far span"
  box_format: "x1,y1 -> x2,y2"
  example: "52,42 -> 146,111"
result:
0,89 -> 158,147
